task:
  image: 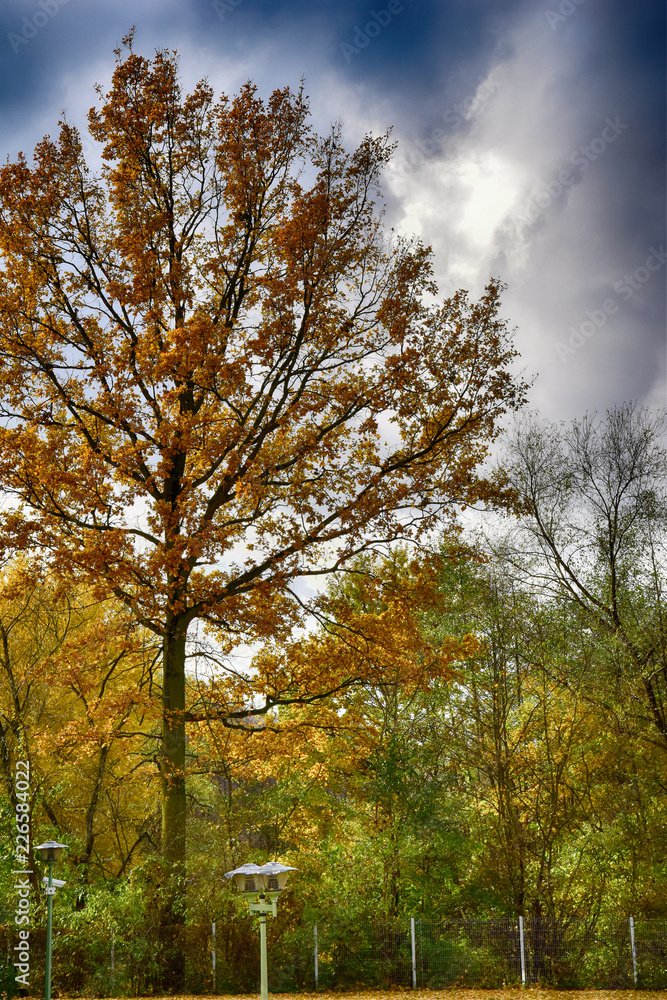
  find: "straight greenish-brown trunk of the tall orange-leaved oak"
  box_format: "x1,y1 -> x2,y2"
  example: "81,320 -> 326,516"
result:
160,621 -> 187,990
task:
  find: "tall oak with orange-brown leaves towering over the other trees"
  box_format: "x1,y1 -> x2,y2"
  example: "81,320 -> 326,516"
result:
0,36 -> 523,952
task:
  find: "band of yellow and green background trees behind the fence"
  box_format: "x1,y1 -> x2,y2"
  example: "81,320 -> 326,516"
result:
0,528 -> 667,993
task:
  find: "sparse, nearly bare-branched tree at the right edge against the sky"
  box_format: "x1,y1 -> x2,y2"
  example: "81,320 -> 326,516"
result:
504,404 -> 667,750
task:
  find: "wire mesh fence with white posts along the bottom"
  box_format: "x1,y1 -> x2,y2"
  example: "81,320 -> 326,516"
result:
0,913 -> 667,997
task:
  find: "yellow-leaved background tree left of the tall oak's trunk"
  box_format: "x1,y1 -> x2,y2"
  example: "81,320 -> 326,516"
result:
0,562 -> 157,884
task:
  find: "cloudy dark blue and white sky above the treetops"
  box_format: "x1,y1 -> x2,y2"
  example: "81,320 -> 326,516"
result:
0,0 -> 667,420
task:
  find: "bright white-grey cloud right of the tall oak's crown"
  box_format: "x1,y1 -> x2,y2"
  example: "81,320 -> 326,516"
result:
374,4 -> 665,419
